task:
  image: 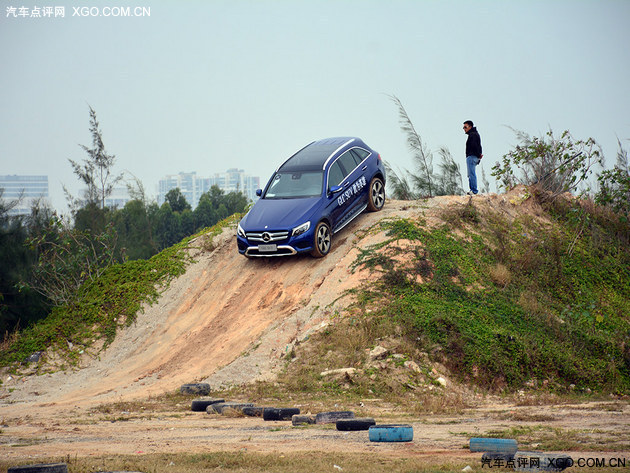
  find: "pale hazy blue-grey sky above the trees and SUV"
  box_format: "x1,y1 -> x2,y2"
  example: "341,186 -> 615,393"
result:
0,0 -> 630,208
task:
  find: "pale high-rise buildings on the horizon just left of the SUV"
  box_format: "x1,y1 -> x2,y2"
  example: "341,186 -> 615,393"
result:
157,168 -> 260,209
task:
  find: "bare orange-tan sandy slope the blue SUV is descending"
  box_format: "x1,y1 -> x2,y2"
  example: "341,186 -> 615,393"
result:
0,197 -> 421,413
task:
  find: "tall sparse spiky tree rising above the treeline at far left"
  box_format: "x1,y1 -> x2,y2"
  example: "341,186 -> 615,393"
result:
64,107 -> 122,209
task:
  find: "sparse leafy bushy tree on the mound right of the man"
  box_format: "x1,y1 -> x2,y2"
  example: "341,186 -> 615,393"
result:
491,130 -> 603,198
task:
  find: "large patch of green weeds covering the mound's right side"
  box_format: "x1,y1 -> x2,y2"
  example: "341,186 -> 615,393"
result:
356,208 -> 630,393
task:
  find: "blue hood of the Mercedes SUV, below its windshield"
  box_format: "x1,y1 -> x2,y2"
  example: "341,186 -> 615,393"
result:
241,197 -> 321,231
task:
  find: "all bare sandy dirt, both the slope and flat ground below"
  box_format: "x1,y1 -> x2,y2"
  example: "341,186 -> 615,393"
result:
0,193 -> 630,471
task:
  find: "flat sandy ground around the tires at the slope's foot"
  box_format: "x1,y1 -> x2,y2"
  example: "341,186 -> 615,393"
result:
0,401 -> 630,471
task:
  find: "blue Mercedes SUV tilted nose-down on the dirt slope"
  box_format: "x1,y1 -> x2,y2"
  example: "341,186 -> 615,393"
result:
237,137 -> 385,258
